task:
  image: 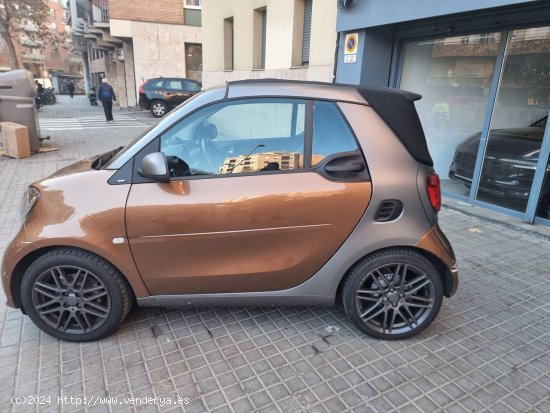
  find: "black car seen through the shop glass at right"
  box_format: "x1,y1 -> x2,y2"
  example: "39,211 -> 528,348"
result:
449,116 -> 550,216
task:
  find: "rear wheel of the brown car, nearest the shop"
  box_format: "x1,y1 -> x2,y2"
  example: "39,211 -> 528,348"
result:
342,249 -> 443,340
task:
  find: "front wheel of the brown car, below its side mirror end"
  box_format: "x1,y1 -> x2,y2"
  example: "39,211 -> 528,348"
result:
21,248 -> 132,341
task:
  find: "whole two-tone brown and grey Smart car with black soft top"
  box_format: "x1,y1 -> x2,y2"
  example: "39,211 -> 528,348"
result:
1,80 -> 458,341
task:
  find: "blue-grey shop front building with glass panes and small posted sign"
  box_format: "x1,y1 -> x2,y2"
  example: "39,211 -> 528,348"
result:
336,0 -> 550,225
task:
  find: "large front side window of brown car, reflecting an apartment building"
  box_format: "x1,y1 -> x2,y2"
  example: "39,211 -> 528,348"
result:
160,98 -> 306,178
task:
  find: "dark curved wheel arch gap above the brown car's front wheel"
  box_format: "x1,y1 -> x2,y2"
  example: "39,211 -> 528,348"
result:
10,245 -> 136,308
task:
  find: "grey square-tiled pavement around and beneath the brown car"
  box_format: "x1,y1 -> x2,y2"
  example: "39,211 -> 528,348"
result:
0,97 -> 550,413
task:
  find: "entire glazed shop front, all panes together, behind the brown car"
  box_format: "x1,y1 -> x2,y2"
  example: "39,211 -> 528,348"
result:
399,27 -> 550,224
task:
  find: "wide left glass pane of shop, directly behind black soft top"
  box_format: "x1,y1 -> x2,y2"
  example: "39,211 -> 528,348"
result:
399,33 -> 501,196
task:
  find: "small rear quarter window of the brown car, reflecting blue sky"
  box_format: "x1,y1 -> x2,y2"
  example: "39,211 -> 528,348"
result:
311,101 -> 358,165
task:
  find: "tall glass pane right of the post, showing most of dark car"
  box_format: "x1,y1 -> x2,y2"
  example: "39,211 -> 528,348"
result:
477,27 -> 550,212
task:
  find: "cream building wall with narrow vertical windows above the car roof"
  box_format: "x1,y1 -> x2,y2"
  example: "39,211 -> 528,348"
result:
202,0 -> 336,87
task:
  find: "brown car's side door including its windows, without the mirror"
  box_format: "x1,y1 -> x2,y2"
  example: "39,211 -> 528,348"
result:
126,98 -> 371,295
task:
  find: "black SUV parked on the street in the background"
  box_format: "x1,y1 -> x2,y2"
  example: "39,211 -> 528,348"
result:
139,77 -> 201,118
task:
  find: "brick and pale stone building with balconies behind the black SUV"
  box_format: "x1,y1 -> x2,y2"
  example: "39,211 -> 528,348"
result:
71,0 -> 202,106
